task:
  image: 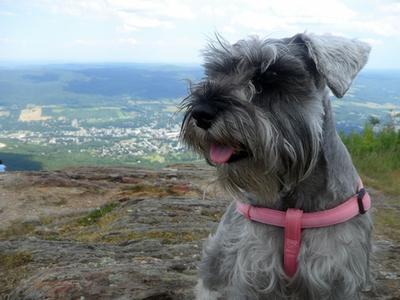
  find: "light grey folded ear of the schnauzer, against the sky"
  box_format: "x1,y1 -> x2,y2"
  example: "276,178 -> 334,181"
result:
292,34 -> 371,98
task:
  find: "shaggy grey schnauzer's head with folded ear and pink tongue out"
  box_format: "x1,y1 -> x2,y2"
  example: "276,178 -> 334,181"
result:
181,34 -> 370,203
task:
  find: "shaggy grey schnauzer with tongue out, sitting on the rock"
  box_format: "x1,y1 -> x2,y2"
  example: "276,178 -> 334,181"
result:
181,34 -> 372,300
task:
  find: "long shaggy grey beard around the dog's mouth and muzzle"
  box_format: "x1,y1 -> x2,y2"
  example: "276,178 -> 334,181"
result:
181,108 -> 278,206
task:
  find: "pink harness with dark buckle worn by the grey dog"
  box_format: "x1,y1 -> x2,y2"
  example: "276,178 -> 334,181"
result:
236,180 -> 371,277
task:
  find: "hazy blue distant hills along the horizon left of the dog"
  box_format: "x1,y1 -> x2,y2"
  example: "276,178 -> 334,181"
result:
0,64 -> 203,106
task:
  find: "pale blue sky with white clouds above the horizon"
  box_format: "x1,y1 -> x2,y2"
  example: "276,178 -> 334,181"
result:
0,0 -> 400,69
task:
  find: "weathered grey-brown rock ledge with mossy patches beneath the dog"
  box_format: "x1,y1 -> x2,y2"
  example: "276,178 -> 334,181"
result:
0,165 -> 400,300
